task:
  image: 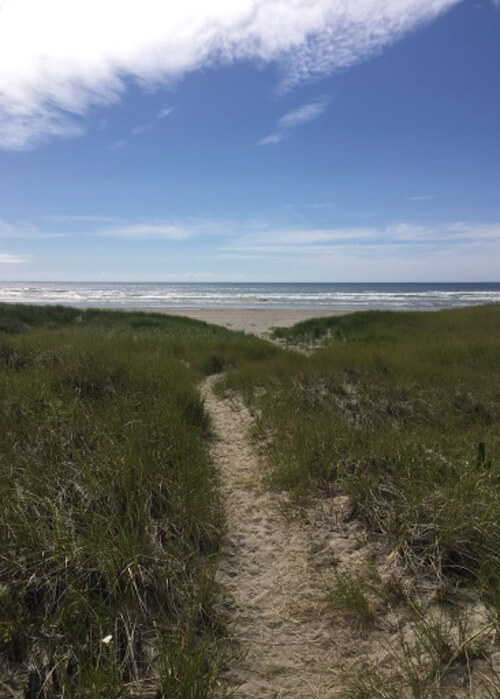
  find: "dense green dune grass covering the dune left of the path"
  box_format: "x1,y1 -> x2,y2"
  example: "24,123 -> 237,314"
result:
0,306 -> 276,699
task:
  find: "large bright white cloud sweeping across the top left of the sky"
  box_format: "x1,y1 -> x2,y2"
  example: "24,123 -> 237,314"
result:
0,0 -> 460,149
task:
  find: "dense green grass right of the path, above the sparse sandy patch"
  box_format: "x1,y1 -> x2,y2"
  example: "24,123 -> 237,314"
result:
226,306 -> 500,604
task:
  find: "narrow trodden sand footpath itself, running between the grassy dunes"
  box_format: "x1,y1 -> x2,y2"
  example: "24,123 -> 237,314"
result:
203,377 -> 370,697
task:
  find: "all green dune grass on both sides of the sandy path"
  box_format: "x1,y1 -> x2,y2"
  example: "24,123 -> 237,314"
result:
0,306 -> 500,698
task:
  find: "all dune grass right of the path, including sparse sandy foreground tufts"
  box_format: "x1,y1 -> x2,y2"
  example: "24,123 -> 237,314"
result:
225,306 -> 500,699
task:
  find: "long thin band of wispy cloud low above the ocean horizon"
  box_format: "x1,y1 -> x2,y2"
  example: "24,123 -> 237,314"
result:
4,219 -> 500,257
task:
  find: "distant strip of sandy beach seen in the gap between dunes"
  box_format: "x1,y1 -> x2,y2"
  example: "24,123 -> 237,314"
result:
126,308 -> 349,337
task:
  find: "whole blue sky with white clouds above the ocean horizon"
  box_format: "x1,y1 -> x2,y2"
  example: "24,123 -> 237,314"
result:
0,0 -> 500,282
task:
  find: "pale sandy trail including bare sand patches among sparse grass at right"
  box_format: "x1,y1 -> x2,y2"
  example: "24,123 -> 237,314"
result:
198,376 -> 500,699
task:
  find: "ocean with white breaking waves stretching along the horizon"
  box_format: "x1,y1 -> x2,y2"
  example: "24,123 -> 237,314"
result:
0,282 -> 500,310
